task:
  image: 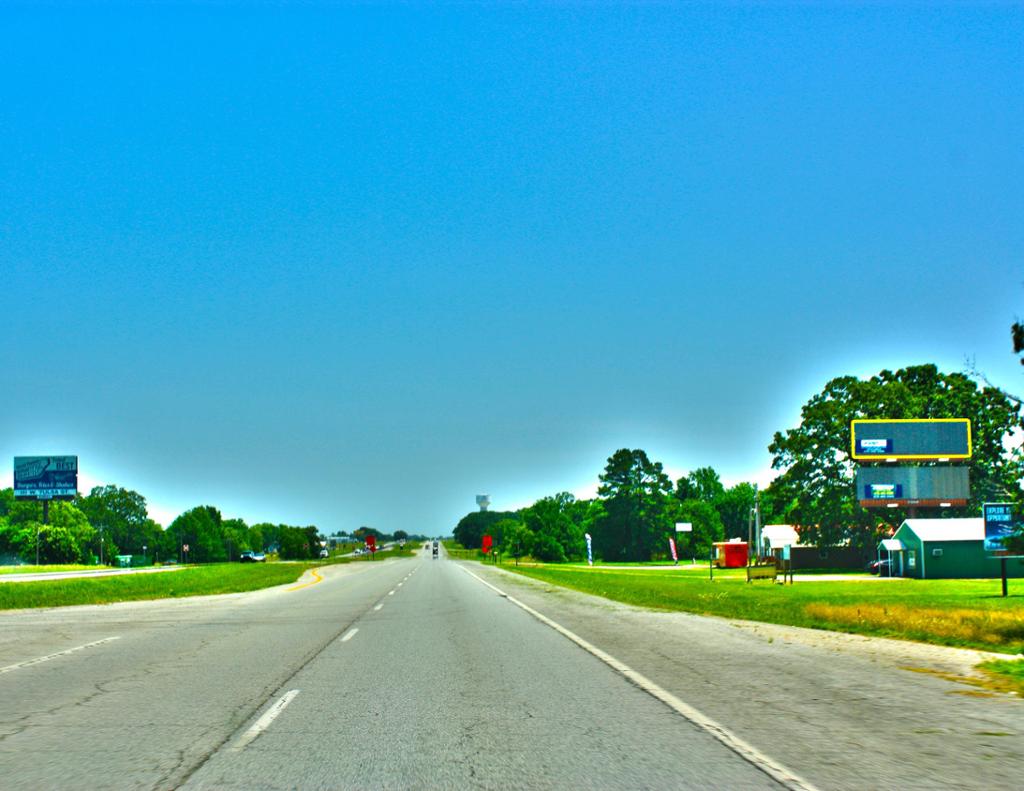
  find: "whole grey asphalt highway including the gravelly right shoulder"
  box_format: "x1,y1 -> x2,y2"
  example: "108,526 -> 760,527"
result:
0,553 -> 1024,789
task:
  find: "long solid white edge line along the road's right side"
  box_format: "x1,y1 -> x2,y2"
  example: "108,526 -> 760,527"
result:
459,566 -> 818,791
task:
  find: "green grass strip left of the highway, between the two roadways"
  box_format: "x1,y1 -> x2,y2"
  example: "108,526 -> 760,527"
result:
0,563 -> 318,610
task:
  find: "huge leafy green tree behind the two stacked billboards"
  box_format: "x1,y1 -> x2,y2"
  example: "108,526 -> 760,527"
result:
769,365 -> 1024,545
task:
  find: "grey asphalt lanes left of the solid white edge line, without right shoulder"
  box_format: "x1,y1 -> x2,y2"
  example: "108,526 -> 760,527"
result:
0,553 -> 779,789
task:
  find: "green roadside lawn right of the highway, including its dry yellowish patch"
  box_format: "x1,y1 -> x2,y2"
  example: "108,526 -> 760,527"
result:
506,566 -> 1024,654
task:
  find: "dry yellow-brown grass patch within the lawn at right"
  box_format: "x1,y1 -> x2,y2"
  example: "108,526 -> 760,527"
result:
805,602 -> 1024,646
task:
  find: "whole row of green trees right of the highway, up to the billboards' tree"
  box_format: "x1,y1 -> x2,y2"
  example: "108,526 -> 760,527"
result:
454,365 -> 1024,561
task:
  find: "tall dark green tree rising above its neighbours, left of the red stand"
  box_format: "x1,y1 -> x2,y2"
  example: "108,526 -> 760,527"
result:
594,448 -> 674,561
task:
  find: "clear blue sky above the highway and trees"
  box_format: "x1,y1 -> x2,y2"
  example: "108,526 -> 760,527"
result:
0,3 -> 1024,533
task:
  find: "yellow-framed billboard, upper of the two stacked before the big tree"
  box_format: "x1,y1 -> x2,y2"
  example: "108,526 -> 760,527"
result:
850,418 -> 971,461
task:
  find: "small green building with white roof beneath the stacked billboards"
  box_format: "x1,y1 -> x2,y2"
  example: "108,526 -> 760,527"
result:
878,518 -> 1024,580
